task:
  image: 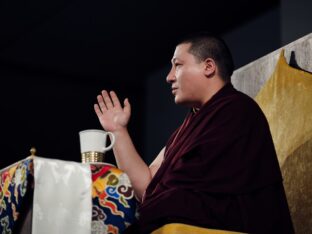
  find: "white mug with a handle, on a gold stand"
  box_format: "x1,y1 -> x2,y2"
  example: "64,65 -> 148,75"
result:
79,129 -> 115,161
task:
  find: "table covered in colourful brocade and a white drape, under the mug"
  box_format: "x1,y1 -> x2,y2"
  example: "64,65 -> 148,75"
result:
0,156 -> 136,234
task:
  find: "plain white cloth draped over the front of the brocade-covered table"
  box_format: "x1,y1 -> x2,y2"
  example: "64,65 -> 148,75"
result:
32,157 -> 92,234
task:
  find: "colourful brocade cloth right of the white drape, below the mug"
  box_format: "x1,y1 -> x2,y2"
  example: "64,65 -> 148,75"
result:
91,164 -> 136,234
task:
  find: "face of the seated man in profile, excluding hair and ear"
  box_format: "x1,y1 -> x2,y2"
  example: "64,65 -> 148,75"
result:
167,43 -> 206,107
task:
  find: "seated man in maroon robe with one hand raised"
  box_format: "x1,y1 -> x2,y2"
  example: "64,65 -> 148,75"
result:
94,33 -> 294,233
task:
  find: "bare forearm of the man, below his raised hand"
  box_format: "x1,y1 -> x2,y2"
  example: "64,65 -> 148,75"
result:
113,128 -> 152,199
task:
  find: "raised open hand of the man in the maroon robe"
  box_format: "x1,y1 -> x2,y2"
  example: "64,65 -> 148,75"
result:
94,90 -> 131,132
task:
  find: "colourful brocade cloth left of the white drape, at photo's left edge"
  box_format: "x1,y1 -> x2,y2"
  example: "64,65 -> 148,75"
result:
0,158 -> 33,234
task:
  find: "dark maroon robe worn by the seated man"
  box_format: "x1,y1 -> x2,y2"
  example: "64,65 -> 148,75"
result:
139,84 -> 293,233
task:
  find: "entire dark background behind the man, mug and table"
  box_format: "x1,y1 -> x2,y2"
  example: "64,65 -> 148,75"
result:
0,0 -> 312,168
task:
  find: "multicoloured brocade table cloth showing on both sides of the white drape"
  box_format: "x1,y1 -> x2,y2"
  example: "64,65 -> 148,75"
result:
0,157 -> 136,234
